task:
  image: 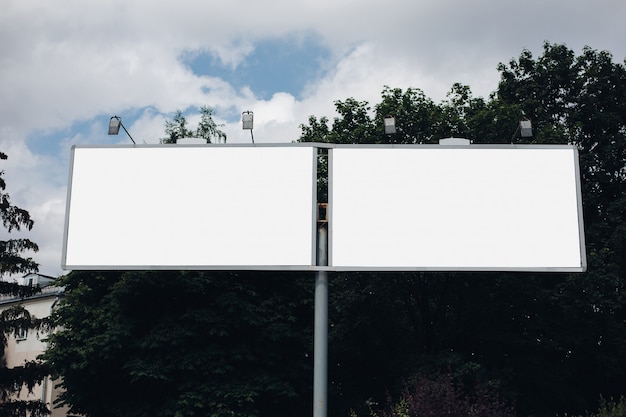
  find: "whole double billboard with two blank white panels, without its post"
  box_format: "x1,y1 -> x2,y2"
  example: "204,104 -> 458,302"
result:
62,143 -> 586,272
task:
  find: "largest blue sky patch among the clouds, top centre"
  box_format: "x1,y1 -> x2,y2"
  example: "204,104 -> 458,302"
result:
183,36 -> 331,100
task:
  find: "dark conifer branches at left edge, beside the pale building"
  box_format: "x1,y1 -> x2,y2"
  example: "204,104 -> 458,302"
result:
0,152 -> 50,417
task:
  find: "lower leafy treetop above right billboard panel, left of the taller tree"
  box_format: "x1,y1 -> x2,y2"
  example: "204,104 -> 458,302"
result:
300,83 -> 521,144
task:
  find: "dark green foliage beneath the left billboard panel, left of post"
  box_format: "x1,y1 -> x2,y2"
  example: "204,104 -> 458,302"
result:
46,271 -> 313,417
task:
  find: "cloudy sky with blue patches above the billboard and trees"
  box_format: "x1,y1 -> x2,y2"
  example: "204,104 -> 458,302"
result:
0,0 -> 626,279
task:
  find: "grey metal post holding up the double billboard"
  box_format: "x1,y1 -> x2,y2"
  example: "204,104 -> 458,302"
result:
313,221 -> 328,417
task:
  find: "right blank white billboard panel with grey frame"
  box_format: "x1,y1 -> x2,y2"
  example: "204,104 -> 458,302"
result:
329,145 -> 586,271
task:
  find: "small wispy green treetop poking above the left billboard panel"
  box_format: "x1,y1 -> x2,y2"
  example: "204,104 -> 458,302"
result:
161,106 -> 226,143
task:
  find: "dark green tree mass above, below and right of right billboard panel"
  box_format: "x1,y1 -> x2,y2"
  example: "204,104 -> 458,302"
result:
301,43 -> 626,416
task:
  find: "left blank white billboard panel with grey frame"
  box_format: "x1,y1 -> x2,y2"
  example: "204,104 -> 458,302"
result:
63,145 -> 315,269
